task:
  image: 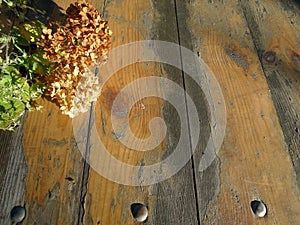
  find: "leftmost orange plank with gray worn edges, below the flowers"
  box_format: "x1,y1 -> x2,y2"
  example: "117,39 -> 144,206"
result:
0,1 -> 84,224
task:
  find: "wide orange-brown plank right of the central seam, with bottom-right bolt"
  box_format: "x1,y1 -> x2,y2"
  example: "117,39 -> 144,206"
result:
176,0 -> 300,224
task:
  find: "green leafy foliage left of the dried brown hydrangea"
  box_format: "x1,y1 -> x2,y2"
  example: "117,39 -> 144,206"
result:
0,9 -> 48,130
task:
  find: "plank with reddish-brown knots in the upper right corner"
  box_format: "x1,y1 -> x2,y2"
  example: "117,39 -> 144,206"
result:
242,1 -> 300,185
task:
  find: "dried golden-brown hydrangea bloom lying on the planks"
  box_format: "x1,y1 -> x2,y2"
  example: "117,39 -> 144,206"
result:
39,1 -> 112,117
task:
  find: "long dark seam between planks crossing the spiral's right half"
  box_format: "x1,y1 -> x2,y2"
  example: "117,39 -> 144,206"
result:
174,0 -> 200,225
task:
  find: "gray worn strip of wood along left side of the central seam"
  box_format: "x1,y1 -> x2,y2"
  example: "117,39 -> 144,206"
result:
151,1 -> 200,225
